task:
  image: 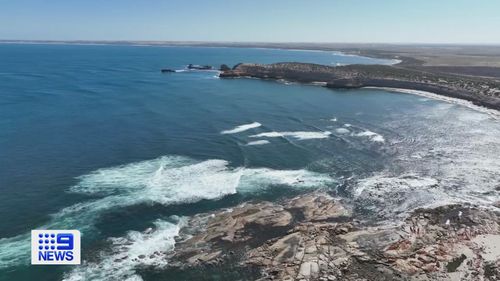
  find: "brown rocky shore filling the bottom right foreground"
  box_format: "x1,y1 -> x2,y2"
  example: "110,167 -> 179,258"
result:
162,193 -> 500,281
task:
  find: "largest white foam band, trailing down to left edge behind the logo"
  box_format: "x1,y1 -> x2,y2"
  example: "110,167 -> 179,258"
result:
0,156 -> 333,268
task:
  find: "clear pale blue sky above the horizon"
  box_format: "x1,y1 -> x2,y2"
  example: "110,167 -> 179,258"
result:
0,0 -> 500,44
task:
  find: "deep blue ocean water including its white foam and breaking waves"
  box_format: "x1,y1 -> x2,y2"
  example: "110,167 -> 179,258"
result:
0,45 -> 500,280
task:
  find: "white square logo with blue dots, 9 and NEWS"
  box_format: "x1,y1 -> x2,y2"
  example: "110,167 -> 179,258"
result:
31,230 -> 80,265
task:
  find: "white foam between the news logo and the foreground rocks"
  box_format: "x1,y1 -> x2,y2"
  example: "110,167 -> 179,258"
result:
63,220 -> 184,281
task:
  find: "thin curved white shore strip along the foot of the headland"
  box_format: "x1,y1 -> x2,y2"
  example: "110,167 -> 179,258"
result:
363,87 -> 500,119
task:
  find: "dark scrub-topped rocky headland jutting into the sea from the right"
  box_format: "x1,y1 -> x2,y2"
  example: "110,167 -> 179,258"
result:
219,62 -> 500,110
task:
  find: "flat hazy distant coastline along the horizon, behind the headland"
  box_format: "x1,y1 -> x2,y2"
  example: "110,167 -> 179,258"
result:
0,39 -> 500,77
